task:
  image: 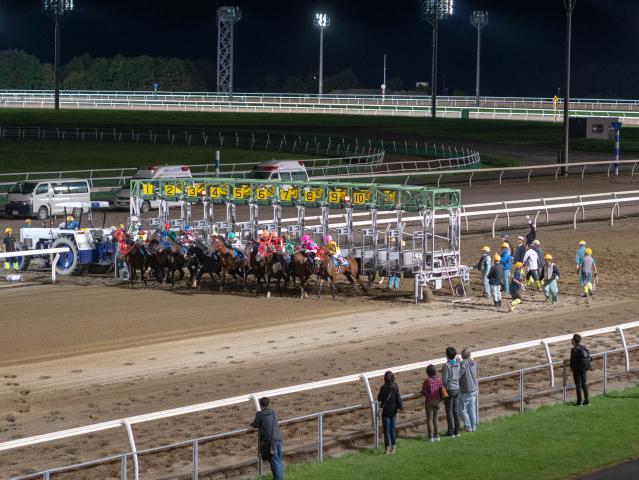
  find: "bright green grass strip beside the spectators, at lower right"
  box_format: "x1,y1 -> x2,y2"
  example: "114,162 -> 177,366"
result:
284,387 -> 639,480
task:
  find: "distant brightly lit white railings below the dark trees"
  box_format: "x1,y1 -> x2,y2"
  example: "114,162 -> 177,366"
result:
6,91 -> 639,124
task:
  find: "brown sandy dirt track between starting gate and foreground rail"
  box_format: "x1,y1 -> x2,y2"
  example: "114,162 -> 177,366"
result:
0,177 -> 639,478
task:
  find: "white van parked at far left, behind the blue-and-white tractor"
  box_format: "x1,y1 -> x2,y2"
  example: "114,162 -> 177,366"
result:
4,178 -> 91,221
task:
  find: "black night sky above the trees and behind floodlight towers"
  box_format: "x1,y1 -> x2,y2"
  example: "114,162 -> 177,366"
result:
0,0 -> 639,96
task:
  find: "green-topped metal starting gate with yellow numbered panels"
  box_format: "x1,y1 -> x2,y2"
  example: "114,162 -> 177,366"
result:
131,177 -> 469,300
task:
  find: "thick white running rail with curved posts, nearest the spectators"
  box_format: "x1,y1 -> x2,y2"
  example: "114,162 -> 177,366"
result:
0,321 -> 639,480
